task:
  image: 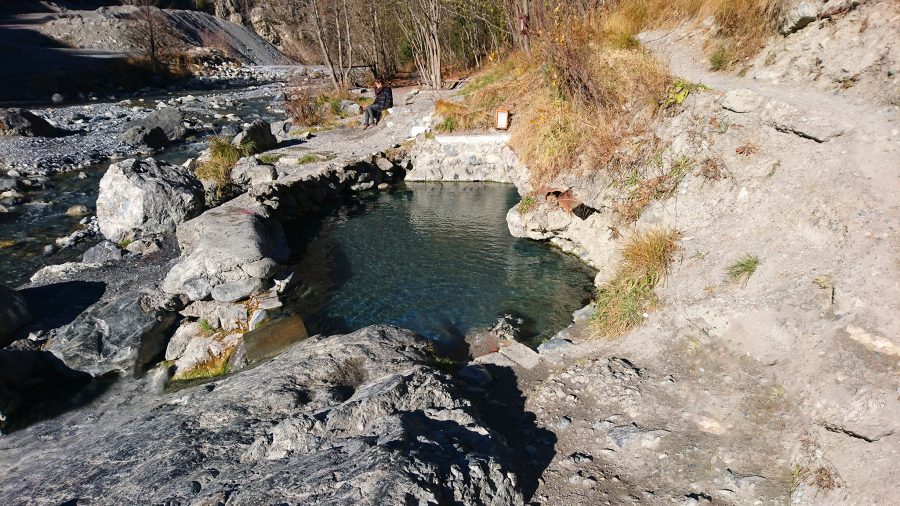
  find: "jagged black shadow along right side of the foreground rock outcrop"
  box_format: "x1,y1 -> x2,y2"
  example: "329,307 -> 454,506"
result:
467,364 -> 556,503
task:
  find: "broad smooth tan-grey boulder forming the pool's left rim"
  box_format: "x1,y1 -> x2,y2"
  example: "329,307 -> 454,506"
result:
162,198 -> 288,302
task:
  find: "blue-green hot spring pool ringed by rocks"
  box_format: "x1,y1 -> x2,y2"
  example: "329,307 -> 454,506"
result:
286,183 -> 594,343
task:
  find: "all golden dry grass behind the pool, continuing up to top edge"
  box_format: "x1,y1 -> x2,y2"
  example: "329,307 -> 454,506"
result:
437,0 -> 782,186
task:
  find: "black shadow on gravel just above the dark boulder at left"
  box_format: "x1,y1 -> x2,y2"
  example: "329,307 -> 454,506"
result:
19,281 -> 106,331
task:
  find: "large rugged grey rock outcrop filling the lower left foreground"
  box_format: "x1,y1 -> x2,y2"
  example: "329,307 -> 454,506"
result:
0,326 -> 523,505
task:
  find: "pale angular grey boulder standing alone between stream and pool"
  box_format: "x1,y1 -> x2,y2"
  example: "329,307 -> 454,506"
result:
97,158 -> 204,242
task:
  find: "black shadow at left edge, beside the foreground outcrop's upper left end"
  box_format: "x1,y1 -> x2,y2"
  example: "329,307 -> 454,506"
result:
0,350 -> 112,433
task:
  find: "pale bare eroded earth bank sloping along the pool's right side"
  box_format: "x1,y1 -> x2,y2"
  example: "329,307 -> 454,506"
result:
413,11 -> 900,504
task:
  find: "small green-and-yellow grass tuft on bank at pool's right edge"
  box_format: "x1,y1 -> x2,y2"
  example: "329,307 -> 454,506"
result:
591,228 -> 681,337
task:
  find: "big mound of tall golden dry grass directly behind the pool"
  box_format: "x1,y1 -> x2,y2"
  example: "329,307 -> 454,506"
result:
446,27 -> 672,185
